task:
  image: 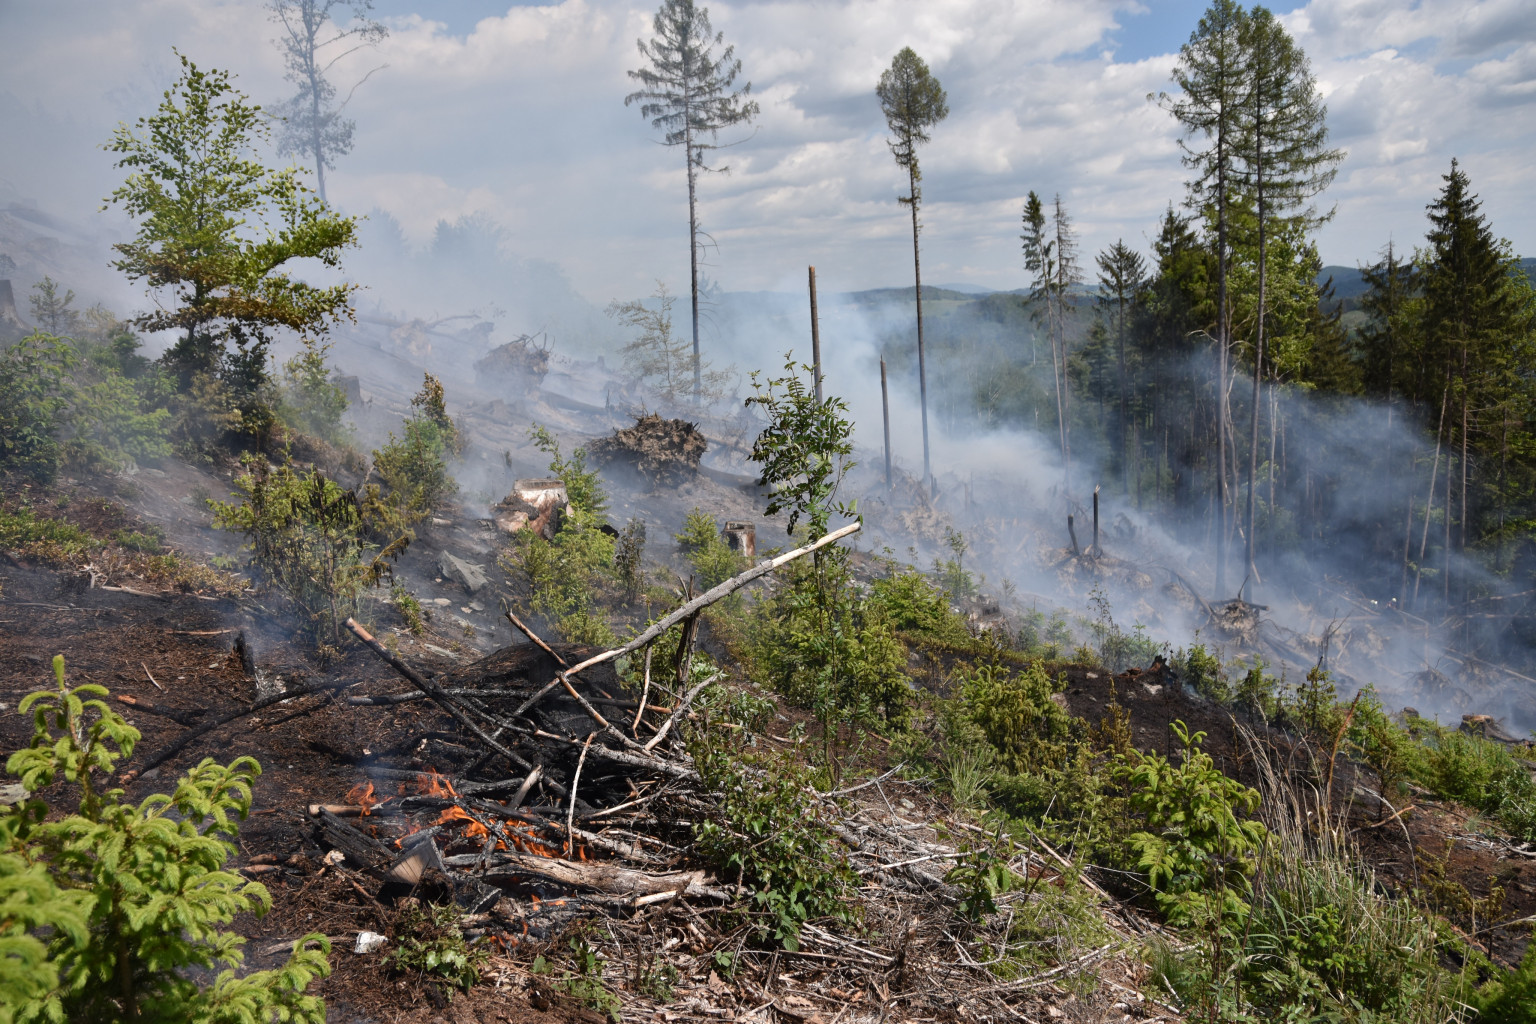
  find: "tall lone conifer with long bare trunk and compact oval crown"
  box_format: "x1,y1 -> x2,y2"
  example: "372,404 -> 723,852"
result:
876,46 -> 949,488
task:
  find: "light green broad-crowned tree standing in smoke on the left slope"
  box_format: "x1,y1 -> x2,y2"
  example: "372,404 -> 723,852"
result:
106,54 -> 356,411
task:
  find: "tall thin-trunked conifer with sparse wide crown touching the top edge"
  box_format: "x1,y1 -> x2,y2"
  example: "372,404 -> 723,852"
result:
624,0 -> 757,401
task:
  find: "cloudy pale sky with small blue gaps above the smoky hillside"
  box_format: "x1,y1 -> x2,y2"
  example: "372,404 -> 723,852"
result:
0,0 -> 1536,304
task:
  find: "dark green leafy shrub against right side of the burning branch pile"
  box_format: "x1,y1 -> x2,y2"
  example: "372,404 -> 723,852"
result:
693,734 -> 857,950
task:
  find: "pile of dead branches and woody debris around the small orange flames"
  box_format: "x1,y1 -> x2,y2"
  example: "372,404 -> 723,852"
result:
124,524 -> 1175,1024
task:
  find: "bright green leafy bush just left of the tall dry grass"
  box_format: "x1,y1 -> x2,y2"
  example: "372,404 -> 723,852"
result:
1117,722 -> 1269,924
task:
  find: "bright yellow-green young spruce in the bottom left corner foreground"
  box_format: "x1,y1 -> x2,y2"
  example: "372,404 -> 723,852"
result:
0,657 -> 330,1024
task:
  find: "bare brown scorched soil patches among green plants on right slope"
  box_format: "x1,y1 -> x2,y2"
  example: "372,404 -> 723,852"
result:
1064,666 -> 1536,966
